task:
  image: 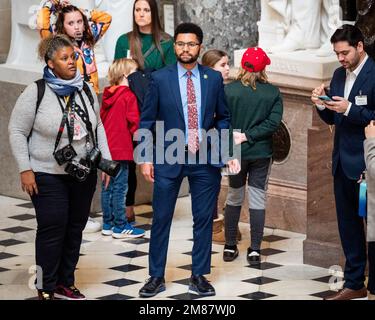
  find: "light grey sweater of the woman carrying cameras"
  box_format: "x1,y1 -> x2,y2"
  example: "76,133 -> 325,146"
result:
8,83 -> 111,174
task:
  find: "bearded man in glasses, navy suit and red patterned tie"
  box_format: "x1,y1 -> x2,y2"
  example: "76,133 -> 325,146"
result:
138,23 -> 230,297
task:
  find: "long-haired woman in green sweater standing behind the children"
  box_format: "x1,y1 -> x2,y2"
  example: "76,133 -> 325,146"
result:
115,0 -> 176,222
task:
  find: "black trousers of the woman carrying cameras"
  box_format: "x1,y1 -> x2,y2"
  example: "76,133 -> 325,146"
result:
31,172 -> 97,291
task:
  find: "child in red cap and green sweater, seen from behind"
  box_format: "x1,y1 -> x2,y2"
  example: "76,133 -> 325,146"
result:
223,48 -> 283,265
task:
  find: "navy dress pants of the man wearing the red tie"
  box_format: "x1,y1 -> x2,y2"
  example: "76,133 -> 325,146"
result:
149,164 -> 221,277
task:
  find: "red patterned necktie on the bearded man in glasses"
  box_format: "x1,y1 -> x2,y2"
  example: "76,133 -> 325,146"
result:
186,71 -> 199,153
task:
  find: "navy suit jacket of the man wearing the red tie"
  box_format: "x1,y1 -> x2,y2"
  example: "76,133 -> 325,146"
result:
140,64 -> 230,178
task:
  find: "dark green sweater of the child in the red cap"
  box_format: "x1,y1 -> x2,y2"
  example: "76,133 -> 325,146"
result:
225,81 -> 283,160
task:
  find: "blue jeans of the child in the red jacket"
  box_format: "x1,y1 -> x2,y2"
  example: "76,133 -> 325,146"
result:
102,161 -> 129,228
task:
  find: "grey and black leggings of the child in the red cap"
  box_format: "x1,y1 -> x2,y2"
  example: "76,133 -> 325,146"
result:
225,158 -> 272,250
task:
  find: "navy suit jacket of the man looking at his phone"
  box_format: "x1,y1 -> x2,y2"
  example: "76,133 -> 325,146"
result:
318,57 -> 375,180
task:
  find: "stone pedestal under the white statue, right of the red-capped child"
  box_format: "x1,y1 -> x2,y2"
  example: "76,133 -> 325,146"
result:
223,51 -> 343,267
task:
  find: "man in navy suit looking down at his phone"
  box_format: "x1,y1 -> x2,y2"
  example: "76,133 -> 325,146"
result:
311,25 -> 375,300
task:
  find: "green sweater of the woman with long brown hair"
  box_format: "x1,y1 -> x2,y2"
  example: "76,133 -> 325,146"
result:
115,33 -> 176,70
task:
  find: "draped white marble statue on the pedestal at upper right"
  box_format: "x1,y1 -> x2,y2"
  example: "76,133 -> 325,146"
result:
258,0 -> 341,55
